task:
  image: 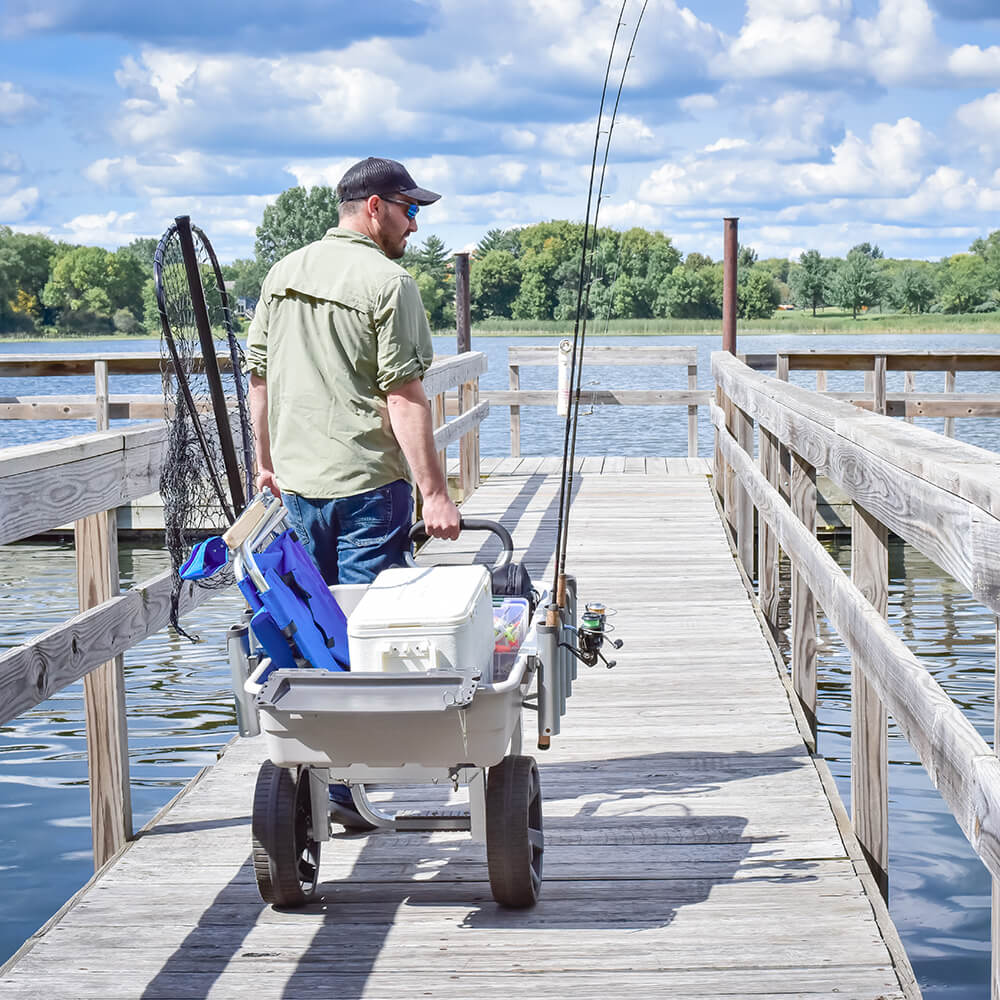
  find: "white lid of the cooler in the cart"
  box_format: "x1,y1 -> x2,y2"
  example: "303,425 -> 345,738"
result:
347,565 -> 490,636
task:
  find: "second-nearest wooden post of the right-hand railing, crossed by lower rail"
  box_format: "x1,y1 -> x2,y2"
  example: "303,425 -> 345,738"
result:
851,503 -> 889,899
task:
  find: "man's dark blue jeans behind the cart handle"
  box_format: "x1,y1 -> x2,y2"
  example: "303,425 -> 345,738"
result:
282,479 -> 413,585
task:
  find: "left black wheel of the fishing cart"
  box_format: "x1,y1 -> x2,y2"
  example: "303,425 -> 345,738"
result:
253,760 -> 320,906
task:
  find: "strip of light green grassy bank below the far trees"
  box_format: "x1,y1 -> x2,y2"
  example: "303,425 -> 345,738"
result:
462,309 -> 1000,337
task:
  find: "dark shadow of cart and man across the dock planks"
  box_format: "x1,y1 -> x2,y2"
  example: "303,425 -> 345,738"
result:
142,747 -> 817,998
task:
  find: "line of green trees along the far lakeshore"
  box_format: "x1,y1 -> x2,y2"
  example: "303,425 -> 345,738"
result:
0,185 -> 1000,335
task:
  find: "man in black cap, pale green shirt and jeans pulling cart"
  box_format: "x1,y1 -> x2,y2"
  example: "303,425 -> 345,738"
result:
247,157 -> 459,584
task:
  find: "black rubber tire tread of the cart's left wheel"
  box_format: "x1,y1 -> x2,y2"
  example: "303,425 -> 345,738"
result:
251,760 -> 320,907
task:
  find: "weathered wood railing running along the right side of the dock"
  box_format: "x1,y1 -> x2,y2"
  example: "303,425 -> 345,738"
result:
711,353 -> 1000,997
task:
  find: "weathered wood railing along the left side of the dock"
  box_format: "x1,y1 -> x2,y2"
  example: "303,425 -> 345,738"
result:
0,352 -> 489,868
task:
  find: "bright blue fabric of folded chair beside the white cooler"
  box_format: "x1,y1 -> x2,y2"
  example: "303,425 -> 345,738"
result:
237,530 -> 350,670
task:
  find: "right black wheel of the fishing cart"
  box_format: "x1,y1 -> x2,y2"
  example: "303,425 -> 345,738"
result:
486,755 -> 545,907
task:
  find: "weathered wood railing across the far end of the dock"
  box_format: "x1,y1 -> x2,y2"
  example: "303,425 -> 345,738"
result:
482,344 -> 711,458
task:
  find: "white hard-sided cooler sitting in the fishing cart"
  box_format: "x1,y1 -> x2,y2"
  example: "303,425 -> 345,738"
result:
347,566 -> 494,684
